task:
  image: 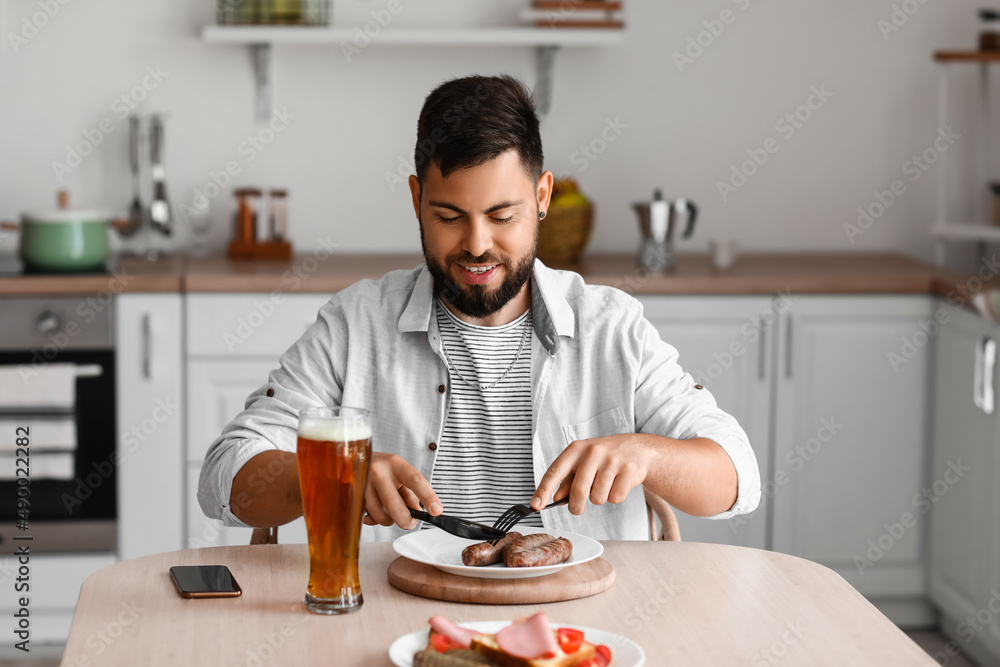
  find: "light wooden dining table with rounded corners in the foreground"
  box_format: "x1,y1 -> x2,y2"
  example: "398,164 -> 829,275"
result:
62,542 -> 937,667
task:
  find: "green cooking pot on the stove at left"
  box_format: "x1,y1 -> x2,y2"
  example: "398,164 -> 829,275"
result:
20,210 -> 112,273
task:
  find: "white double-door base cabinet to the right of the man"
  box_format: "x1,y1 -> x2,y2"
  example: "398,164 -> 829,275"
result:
641,292 -> 933,625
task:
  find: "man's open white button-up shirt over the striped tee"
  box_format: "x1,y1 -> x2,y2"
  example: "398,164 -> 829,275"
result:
198,260 -> 761,541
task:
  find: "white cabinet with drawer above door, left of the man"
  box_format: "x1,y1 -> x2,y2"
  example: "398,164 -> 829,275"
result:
184,292 -> 330,548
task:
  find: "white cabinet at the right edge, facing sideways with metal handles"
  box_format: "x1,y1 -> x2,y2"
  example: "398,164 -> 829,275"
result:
922,302 -> 1000,664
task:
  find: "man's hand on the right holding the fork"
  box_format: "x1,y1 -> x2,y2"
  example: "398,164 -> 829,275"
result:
531,433 -> 654,516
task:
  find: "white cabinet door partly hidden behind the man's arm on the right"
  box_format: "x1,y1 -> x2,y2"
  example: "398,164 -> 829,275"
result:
641,296 -> 772,548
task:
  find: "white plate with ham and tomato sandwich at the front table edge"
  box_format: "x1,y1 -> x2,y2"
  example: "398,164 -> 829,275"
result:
389,612 -> 646,667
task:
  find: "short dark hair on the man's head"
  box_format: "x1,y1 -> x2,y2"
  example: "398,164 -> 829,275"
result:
413,74 -> 544,184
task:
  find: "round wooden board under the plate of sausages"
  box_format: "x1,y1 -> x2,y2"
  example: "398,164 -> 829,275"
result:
388,556 -> 615,604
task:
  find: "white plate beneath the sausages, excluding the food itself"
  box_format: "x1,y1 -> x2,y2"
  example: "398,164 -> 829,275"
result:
392,527 -> 604,579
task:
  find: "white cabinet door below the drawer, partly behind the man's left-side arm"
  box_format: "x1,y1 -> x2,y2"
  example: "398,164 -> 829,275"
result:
186,354 -> 306,548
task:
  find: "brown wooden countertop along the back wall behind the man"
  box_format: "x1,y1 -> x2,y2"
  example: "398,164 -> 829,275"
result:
0,253 -> 979,296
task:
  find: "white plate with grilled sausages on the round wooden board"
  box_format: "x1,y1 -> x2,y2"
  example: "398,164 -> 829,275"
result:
392,528 -> 604,579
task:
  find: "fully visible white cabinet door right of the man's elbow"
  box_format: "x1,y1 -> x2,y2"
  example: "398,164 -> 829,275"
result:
773,296 -> 934,598
